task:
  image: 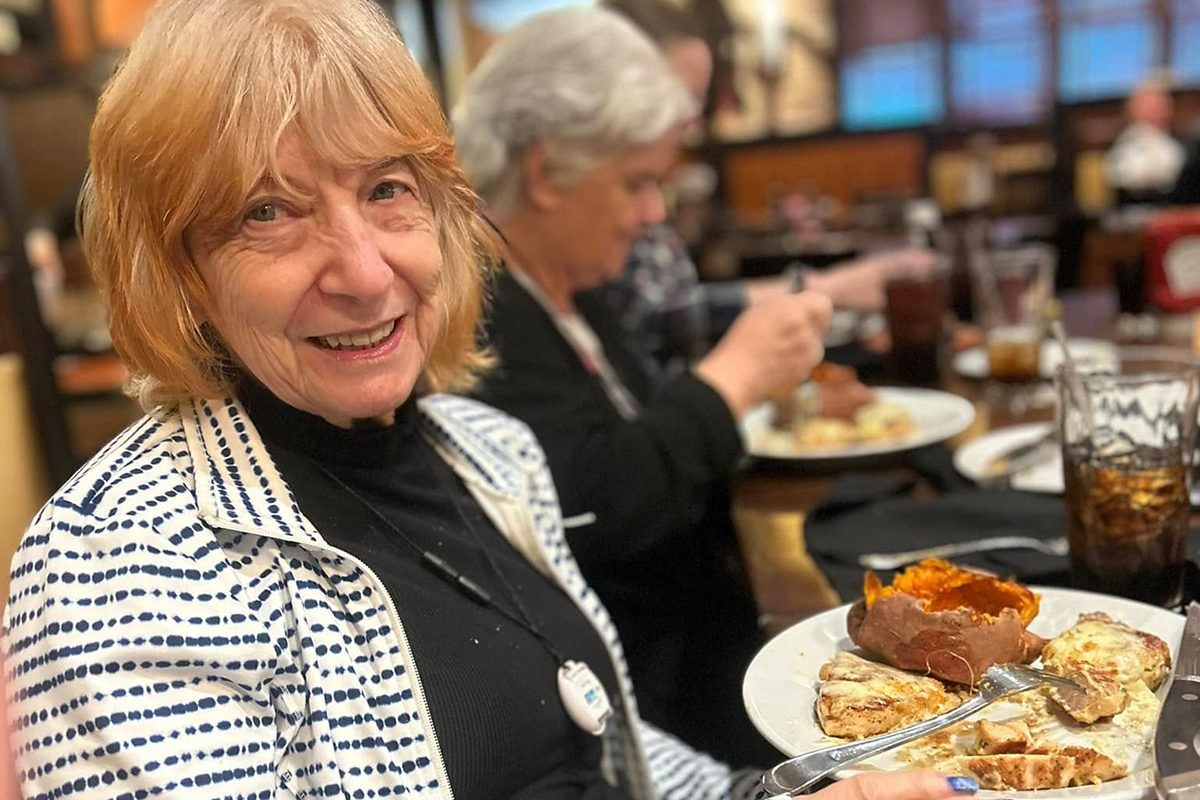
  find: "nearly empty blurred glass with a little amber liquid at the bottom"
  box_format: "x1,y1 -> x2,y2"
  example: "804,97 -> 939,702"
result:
972,245 -> 1056,410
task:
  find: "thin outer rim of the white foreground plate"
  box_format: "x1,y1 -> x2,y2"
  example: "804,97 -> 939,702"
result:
742,584 -> 1186,800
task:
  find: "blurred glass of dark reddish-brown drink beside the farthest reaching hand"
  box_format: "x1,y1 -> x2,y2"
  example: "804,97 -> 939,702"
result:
887,272 -> 947,384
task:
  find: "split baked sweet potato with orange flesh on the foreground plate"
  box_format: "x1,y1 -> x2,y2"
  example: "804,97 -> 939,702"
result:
846,559 -> 1045,685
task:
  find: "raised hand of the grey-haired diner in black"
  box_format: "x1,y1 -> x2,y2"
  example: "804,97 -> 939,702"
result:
696,291 -> 833,419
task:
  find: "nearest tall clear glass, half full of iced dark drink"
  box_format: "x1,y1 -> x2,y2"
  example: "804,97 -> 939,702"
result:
1055,365 -> 1200,607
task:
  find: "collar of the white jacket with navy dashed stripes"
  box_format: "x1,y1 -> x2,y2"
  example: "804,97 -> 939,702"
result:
180,395 -> 526,545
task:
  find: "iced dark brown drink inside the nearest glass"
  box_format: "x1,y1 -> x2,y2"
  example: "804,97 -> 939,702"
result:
1063,447 -> 1192,607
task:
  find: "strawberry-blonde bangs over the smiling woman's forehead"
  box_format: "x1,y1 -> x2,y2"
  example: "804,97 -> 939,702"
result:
168,0 -> 452,235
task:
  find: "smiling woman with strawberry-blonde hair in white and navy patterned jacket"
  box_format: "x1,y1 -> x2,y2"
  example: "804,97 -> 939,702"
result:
5,0 -> 979,800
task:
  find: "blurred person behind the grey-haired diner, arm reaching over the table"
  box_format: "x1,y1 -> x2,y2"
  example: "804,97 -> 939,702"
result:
598,0 -> 934,380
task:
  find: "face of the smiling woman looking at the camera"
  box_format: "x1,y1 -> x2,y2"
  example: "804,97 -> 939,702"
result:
187,139 -> 442,427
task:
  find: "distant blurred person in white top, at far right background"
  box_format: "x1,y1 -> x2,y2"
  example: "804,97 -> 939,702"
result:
1104,77 -> 1187,204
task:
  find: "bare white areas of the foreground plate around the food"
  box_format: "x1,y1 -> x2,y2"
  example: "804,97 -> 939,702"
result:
742,587 -> 1184,800
